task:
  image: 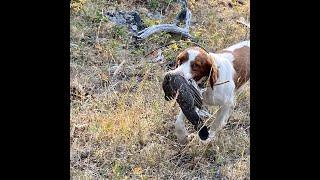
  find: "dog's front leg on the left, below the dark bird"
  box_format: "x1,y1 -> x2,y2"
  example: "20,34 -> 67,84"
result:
175,110 -> 188,144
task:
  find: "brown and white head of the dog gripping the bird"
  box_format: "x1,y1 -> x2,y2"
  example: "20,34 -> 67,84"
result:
167,47 -> 217,87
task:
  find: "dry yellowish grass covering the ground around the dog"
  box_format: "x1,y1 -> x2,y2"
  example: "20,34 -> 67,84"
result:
70,0 -> 250,179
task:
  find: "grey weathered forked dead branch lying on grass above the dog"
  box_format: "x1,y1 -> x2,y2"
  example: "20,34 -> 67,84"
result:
137,0 -> 192,39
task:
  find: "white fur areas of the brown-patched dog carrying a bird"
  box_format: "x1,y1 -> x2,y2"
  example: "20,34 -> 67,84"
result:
169,41 -> 250,142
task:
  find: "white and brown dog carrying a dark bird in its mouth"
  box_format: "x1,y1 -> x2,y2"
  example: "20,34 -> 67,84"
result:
167,41 -> 250,142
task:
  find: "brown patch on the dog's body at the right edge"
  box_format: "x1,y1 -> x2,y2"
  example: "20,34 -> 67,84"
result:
232,46 -> 250,89
